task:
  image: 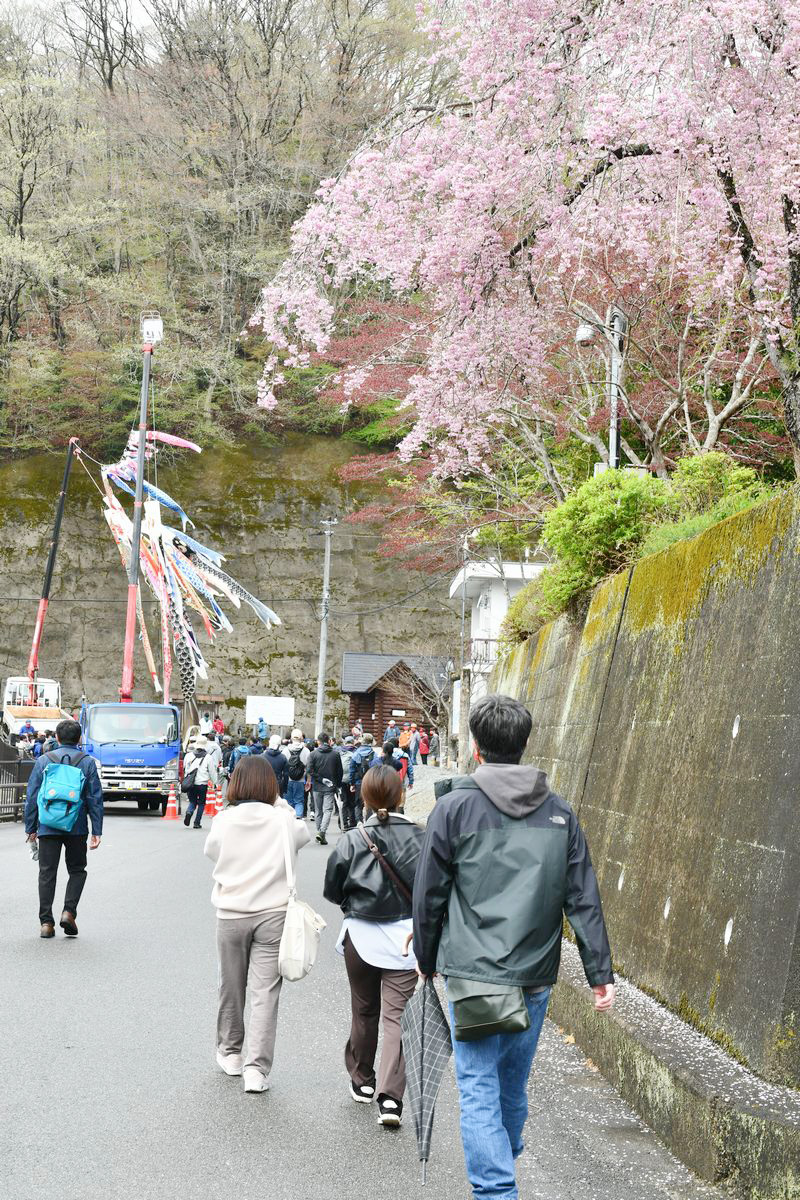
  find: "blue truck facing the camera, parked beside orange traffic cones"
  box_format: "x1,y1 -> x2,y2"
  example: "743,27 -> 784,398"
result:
80,703 -> 181,812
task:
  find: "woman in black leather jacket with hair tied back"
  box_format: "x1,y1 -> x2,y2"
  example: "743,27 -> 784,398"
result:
324,766 -> 423,1127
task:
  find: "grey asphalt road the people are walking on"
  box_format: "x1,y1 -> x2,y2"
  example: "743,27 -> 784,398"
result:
0,808 -> 720,1200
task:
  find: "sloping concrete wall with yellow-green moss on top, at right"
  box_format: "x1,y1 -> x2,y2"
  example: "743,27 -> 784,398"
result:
494,492 -> 800,1086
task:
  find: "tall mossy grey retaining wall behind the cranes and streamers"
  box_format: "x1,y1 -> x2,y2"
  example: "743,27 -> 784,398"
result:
0,436 -> 457,732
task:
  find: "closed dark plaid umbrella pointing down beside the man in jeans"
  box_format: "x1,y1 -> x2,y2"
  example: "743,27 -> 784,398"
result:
403,979 -> 452,1183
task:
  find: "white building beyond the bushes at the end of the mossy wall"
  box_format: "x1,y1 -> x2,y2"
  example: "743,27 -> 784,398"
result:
450,558 -> 546,733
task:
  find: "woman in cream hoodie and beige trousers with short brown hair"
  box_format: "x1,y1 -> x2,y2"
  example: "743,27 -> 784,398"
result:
205,755 -> 311,1092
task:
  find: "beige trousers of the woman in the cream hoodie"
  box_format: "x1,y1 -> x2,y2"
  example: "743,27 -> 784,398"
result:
217,911 -> 287,1075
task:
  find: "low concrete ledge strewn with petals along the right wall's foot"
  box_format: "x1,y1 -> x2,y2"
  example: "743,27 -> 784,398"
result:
551,941 -> 800,1200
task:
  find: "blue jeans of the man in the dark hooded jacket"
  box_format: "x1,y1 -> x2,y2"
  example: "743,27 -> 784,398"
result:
450,988 -> 551,1200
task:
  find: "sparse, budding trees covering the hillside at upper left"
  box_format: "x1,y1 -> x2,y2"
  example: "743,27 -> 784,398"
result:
0,0 -> 441,455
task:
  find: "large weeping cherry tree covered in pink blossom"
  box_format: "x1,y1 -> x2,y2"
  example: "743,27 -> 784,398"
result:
252,0 -> 800,475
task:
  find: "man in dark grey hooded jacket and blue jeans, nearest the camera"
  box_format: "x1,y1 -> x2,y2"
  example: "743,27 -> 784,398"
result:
414,696 -> 614,1200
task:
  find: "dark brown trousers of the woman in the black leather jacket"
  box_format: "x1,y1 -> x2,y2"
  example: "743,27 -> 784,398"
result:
344,935 -> 417,1100
